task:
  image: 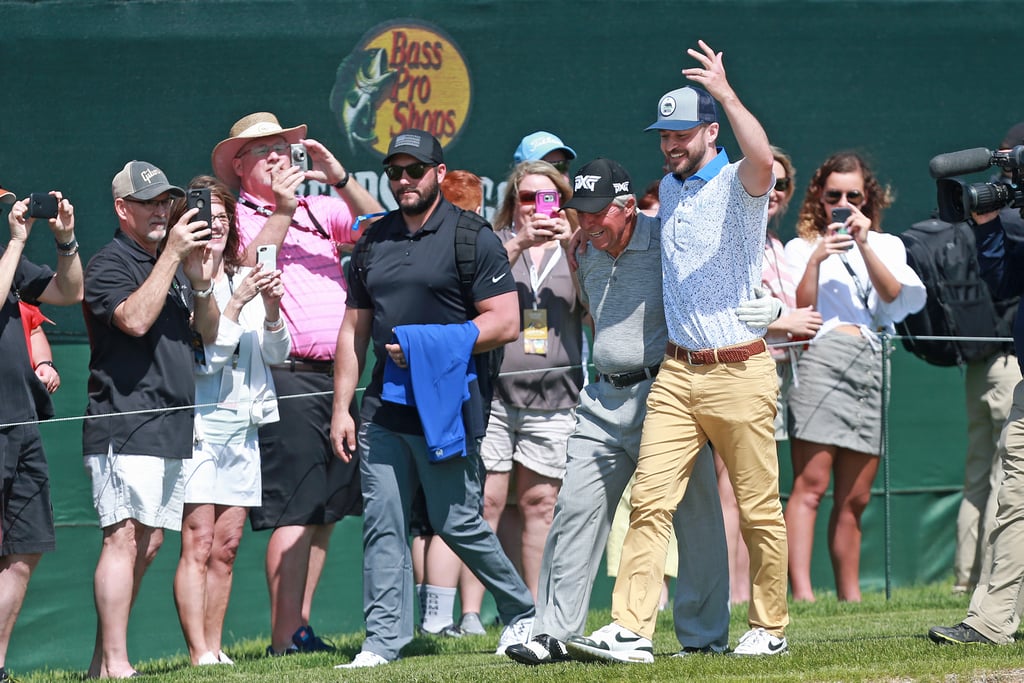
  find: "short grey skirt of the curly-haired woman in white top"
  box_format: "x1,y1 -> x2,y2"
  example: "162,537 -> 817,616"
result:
790,332 -> 882,455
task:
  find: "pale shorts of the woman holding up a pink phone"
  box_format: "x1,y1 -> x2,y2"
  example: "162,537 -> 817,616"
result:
480,399 -> 575,480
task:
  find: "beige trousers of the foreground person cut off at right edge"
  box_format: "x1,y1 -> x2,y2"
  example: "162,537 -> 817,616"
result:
964,382 -> 1024,644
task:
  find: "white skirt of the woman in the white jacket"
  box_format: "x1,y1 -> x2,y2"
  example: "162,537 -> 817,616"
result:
183,438 -> 263,508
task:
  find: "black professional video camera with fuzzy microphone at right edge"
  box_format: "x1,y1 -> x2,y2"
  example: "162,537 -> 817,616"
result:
928,144 -> 1024,223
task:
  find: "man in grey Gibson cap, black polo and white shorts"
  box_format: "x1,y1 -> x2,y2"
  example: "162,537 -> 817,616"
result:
82,161 -> 219,678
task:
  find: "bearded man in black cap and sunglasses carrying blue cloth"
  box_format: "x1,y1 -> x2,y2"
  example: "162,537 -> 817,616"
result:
331,130 -> 534,668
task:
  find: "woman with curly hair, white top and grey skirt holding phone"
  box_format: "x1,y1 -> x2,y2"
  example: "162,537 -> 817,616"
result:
785,152 -> 925,602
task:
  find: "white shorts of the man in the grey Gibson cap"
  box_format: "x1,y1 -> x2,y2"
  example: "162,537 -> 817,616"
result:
85,449 -> 185,531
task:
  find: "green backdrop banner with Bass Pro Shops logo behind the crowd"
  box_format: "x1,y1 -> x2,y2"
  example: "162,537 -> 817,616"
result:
0,0 -> 1024,670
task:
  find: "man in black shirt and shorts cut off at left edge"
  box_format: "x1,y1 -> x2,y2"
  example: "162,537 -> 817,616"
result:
0,187 -> 82,681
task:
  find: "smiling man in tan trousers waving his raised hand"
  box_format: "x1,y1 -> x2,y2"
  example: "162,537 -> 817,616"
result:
567,41 -> 790,663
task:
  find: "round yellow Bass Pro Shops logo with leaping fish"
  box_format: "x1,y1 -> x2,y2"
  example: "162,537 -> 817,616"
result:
331,20 -> 472,157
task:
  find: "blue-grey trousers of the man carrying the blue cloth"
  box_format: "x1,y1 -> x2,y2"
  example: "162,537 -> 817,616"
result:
358,424 -> 535,660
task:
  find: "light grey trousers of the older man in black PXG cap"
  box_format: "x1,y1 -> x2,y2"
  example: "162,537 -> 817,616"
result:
534,380 -> 729,651
